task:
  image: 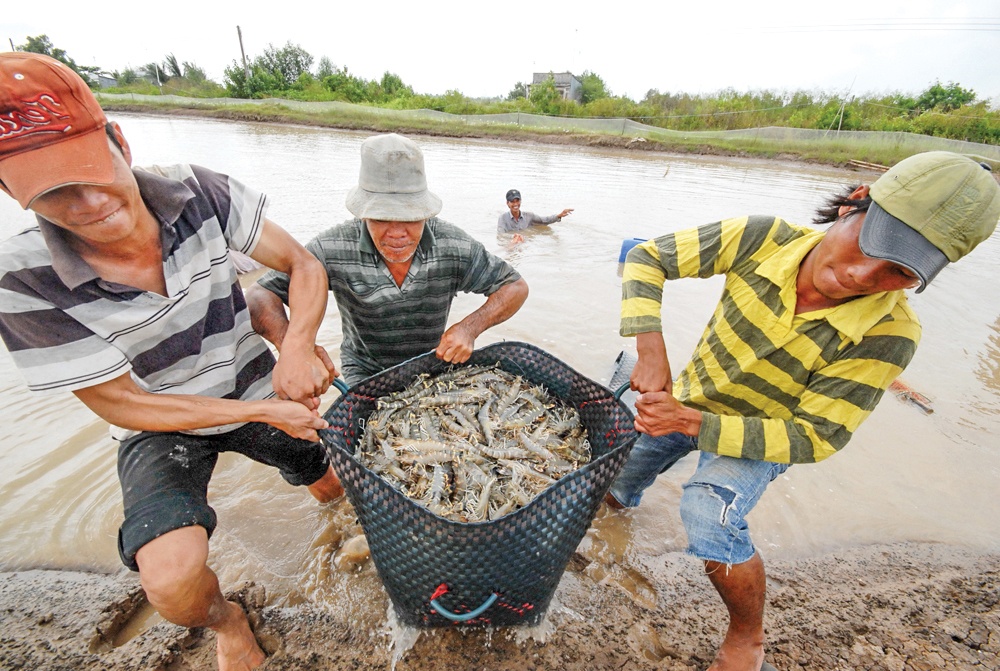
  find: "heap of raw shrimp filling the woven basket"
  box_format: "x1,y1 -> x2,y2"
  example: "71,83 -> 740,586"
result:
357,366 -> 591,522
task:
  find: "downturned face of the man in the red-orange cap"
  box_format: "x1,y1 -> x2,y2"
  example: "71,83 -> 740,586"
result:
28,124 -> 144,244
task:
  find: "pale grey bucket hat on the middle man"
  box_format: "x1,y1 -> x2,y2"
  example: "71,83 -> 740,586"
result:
347,133 -> 441,221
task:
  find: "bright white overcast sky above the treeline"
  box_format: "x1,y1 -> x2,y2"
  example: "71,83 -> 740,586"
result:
0,0 -> 1000,106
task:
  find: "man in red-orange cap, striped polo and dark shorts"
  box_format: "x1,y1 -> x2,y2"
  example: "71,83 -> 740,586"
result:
0,53 -> 343,669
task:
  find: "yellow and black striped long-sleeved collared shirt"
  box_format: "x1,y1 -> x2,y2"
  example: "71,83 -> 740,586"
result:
621,217 -> 920,463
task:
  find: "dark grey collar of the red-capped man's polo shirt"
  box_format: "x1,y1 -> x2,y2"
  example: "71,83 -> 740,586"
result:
35,168 -> 194,290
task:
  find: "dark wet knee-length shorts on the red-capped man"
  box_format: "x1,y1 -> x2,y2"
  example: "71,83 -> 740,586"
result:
118,422 -> 329,571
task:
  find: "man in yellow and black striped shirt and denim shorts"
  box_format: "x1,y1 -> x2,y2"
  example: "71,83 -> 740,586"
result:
608,152 -> 1000,671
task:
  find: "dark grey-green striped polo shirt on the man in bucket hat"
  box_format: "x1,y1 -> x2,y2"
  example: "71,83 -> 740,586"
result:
259,217 -> 521,384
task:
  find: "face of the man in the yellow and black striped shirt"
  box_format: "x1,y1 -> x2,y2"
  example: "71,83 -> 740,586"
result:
803,213 -> 920,300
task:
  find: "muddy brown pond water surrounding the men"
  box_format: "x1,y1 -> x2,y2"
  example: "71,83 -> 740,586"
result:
0,115 -> 1000,618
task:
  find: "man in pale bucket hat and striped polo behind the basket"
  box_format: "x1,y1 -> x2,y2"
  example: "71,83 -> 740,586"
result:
247,134 -> 528,384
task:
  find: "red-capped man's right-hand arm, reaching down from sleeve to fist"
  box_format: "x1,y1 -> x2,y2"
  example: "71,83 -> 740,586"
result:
248,220 -> 330,408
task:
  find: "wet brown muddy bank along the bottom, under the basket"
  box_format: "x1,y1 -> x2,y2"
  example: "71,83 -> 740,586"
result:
0,544 -> 1000,671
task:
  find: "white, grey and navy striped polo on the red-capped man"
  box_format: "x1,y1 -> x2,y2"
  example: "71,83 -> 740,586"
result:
0,165 -> 274,440
